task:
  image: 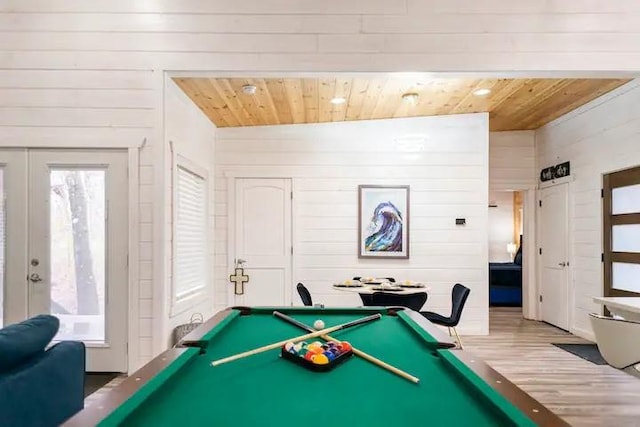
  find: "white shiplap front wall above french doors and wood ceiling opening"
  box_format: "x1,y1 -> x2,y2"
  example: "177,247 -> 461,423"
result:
0,0 -> 640,360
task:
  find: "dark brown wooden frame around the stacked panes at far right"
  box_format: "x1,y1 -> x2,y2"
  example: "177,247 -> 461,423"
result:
602,166 -> 640,297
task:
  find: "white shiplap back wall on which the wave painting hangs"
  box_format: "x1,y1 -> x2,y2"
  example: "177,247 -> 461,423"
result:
216,114 -> 488,333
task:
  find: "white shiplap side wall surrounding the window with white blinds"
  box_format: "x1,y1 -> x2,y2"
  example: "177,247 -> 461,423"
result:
162,78 -> 216,352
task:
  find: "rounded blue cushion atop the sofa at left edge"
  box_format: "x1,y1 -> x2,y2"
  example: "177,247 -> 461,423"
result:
0,314 -> 60,371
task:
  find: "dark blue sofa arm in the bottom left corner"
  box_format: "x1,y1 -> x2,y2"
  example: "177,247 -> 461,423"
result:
0,341 -> 85,427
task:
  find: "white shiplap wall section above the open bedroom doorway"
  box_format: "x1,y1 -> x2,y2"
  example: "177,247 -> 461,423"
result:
489,130 -> 537,191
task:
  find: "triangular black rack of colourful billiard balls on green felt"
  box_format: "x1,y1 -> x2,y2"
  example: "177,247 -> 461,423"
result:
280,341 -> 353,372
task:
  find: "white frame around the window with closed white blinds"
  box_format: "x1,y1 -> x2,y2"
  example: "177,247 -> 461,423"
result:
170,154 -> 210,317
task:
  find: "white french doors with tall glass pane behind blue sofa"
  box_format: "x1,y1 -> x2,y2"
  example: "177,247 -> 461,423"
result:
0,150 -> 128,372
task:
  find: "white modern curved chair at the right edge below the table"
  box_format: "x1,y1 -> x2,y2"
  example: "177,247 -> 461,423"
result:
589,313 -> 640,369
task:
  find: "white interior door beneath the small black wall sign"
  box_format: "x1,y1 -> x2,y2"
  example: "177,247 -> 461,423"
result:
540,184 -> 569,330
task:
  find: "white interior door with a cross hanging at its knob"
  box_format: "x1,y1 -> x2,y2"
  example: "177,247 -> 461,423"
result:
229,178 -> 292,306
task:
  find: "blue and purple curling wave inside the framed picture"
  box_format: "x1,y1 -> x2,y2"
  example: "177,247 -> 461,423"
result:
364,201 -> 403,252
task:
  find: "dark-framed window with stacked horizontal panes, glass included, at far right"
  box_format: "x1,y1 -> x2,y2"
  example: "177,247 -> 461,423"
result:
603,167 -> 640,296
